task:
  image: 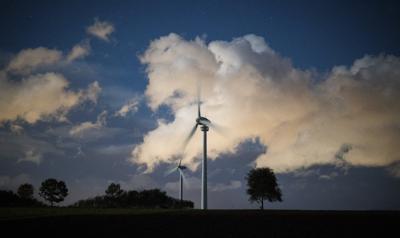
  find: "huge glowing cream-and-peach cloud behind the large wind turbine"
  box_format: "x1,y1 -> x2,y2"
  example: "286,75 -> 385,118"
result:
131,34 -> 400,175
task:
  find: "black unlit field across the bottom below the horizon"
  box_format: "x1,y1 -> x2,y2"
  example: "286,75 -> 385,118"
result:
0,208 -> 400,237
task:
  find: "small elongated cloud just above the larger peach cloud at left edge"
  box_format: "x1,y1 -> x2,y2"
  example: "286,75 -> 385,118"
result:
6,47 -> 63,74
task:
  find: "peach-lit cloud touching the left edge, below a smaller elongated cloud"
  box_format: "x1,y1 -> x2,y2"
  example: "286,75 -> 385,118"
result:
0,73 -> 98,123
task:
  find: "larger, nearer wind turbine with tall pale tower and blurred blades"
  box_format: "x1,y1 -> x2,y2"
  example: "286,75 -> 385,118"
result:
184,88 -> 213,210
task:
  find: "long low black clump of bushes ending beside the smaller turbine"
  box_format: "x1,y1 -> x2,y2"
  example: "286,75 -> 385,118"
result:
72,183 -> 194,208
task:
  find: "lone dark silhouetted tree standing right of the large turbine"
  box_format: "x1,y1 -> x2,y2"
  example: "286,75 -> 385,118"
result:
246,168 -> 282,209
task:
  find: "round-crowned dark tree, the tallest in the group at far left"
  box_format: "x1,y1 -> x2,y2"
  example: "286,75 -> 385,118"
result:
39,178 -> 68,206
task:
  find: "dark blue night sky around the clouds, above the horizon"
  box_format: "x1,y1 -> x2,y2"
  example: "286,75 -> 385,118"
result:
0,0 -> 400,209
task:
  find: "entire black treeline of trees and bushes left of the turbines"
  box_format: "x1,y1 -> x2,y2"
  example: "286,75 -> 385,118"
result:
0,178 -> 194,208
